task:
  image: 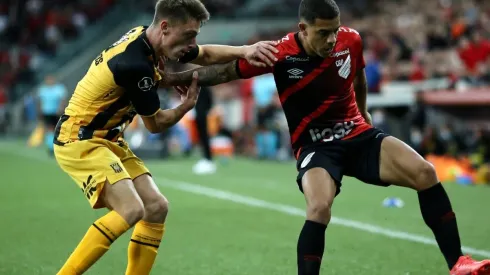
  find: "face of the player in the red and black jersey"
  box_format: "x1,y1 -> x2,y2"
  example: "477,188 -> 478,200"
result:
300,17 -> 340,58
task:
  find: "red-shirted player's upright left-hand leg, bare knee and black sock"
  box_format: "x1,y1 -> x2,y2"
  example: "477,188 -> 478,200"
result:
297,168 -> 337,275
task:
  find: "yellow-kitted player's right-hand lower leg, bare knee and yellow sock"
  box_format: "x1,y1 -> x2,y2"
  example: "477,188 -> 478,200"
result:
126,174 -> 168,275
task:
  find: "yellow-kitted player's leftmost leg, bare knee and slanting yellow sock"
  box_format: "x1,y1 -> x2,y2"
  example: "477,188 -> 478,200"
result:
58,179 -> 144,275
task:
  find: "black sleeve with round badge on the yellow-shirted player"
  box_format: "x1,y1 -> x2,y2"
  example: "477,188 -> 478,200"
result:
114,62 -> 160,116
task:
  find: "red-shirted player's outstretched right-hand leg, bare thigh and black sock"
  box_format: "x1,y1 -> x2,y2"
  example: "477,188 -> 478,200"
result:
380,137 -> 462,269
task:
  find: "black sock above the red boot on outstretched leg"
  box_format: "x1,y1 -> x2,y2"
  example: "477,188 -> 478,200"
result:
418,183 -> 463,269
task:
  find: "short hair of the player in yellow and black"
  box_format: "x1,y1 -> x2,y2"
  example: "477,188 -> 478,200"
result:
153,0 -> 210,24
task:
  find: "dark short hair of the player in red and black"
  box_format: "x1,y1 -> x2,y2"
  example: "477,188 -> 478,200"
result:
299,0 -> 340,23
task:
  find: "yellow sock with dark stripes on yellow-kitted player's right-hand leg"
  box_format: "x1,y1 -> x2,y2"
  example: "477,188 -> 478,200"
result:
126,221 -> 165,275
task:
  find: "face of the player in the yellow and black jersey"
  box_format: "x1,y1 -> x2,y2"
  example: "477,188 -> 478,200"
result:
161,20 -> 201,60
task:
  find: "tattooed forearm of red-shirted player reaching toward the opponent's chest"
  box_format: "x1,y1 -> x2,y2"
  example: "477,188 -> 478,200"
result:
164,60 -> 240,86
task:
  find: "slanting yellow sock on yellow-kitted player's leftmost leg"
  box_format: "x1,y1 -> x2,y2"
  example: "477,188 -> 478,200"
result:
58,211 -> 129,275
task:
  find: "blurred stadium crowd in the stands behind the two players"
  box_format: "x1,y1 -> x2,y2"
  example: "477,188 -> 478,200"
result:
0,0 -> 490,183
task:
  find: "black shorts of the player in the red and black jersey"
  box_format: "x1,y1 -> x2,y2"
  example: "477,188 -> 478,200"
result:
296,128 -> 390,195
